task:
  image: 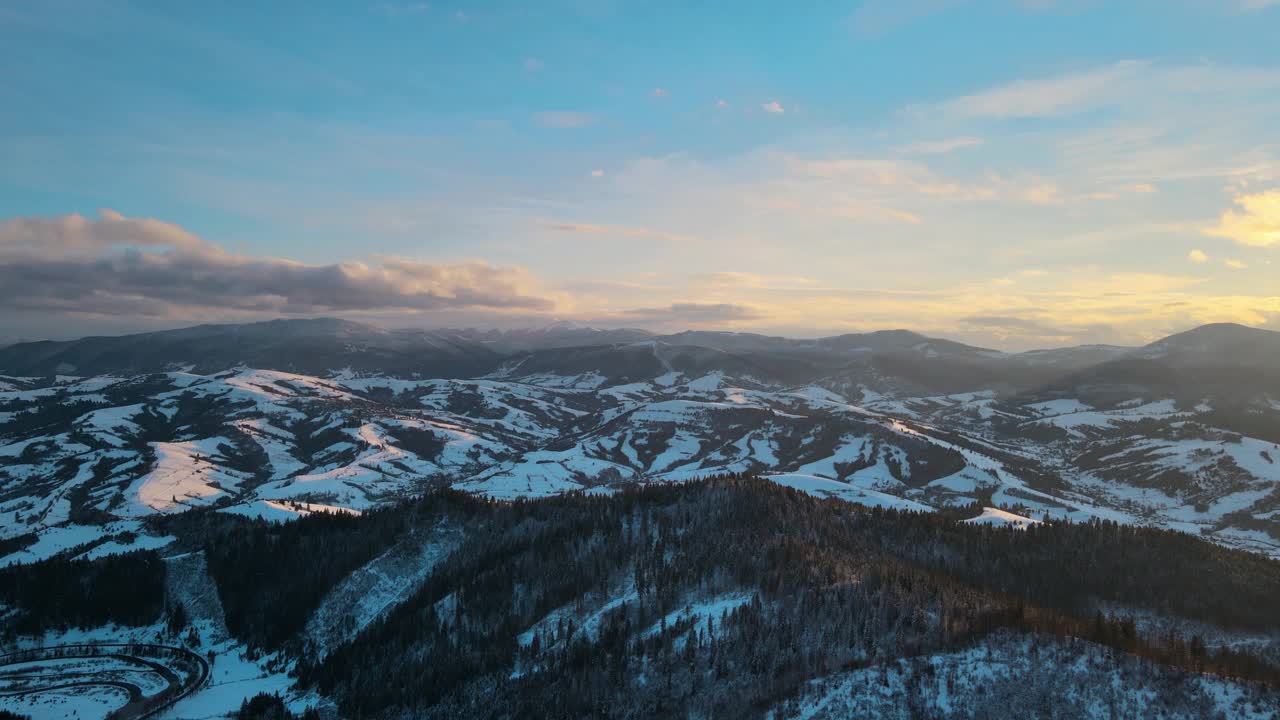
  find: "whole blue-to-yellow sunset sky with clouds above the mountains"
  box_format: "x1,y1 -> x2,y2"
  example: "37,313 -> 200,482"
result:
0,0 -> 1280,350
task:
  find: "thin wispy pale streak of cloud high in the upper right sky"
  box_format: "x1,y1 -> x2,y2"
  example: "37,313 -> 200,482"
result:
942,60 -> 1151,118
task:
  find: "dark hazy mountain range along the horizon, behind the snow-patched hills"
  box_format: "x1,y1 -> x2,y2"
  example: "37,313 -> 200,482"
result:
0,319 -> 1280,401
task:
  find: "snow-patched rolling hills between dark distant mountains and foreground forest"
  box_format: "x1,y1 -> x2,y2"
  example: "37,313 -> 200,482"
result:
0,358 -> 1280,557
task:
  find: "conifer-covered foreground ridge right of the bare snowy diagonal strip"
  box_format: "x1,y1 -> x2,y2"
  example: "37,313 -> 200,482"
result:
290,477 -> 1280,717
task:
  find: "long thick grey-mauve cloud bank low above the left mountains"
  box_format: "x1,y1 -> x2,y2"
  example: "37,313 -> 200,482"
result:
0,210 -> 554,316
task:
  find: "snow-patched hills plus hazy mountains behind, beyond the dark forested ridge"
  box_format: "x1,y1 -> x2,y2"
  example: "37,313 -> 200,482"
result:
0,320 -> 1280,562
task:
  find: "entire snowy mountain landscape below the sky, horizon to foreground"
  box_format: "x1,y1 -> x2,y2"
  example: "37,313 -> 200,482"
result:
0,319 -> 1280,720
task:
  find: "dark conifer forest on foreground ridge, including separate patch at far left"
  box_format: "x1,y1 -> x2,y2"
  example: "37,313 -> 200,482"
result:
3,475 -> 1280,717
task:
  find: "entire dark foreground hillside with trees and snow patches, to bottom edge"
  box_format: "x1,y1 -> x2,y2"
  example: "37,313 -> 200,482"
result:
0,477 -> 1280,719
